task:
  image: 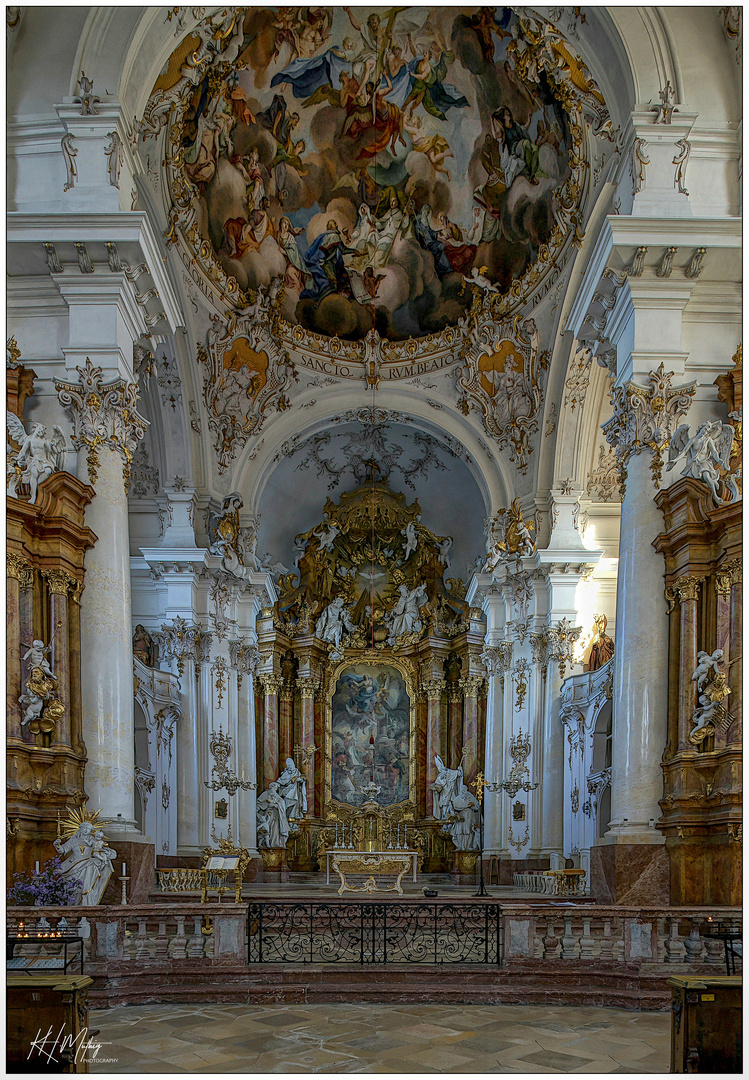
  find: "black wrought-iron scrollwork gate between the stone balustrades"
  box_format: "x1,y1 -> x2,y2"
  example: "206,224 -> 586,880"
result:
247,902 -> 503,967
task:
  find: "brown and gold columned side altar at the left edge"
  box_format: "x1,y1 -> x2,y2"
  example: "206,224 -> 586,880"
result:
6,365 -> 96,877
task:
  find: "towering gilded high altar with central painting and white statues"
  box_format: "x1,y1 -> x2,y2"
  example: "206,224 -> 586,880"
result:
256,477 -> 486,891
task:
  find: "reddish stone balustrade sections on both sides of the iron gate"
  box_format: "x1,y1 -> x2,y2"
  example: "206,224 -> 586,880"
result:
6,900 -> 741,1000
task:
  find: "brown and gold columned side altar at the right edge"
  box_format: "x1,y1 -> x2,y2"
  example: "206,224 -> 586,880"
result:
654,477 -> 743,905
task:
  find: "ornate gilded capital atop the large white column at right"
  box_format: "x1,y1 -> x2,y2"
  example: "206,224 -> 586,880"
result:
602,364 -> 697,498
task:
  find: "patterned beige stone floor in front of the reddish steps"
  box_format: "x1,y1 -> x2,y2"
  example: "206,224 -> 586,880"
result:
91,1003 -> 670,1075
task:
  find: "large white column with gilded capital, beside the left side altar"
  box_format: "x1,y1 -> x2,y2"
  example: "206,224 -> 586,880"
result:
55,360 -> 147,834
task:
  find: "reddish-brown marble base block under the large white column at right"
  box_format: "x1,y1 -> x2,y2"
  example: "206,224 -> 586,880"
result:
590,840 -> 669,907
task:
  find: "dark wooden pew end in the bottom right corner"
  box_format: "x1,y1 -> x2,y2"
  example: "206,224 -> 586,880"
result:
668,975 -> 741,1072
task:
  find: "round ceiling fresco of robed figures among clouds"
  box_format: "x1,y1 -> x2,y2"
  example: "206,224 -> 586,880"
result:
158,8 -> 602,341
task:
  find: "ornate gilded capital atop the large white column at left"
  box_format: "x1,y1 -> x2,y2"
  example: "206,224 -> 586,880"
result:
55,356 -> 148,492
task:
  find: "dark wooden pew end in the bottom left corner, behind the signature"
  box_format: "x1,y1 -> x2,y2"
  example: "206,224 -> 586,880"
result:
6,975 -> 93,1075
